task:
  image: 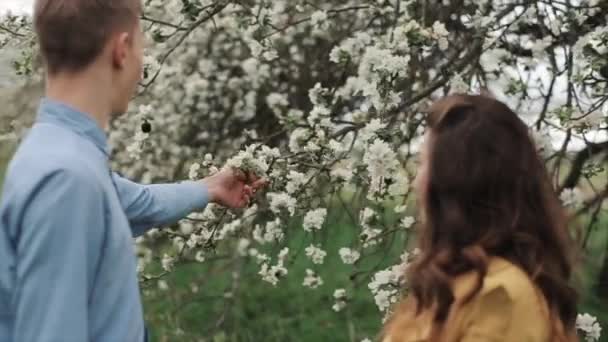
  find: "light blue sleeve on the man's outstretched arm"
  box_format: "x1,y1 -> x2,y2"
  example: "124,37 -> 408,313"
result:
112,173 -> 209,236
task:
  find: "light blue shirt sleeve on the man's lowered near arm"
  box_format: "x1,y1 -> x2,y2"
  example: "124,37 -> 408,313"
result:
12,170 -> 104,342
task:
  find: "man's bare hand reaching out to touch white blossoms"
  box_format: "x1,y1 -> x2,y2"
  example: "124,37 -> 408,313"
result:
203,168 -> 266,208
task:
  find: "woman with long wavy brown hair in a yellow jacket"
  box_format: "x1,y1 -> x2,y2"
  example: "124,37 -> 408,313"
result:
382,95 -> 577,342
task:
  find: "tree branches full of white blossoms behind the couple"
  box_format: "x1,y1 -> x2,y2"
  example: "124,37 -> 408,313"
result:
0,0 -> 608,340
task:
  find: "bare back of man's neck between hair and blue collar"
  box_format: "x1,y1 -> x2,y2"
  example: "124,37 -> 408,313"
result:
46,69 -> 112,130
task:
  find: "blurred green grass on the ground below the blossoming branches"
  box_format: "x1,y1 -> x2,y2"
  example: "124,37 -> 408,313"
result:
144,212 -> 608,342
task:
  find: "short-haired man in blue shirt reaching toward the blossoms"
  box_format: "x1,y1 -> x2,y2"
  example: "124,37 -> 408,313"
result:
0,0 -> 262,342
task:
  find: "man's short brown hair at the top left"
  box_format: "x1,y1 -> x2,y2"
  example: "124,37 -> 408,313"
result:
34,0 -> 142,74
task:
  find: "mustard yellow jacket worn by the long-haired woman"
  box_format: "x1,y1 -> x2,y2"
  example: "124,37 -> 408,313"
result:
383,258 -> 551,342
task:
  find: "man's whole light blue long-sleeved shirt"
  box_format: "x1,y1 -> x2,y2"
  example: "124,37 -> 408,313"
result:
0,99 -> 208,342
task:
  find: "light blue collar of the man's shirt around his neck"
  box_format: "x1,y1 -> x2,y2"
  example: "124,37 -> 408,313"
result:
36,98 -> 110,156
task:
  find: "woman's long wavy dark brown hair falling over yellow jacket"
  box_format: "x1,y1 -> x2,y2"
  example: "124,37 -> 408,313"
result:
387,95 -> 577,341
